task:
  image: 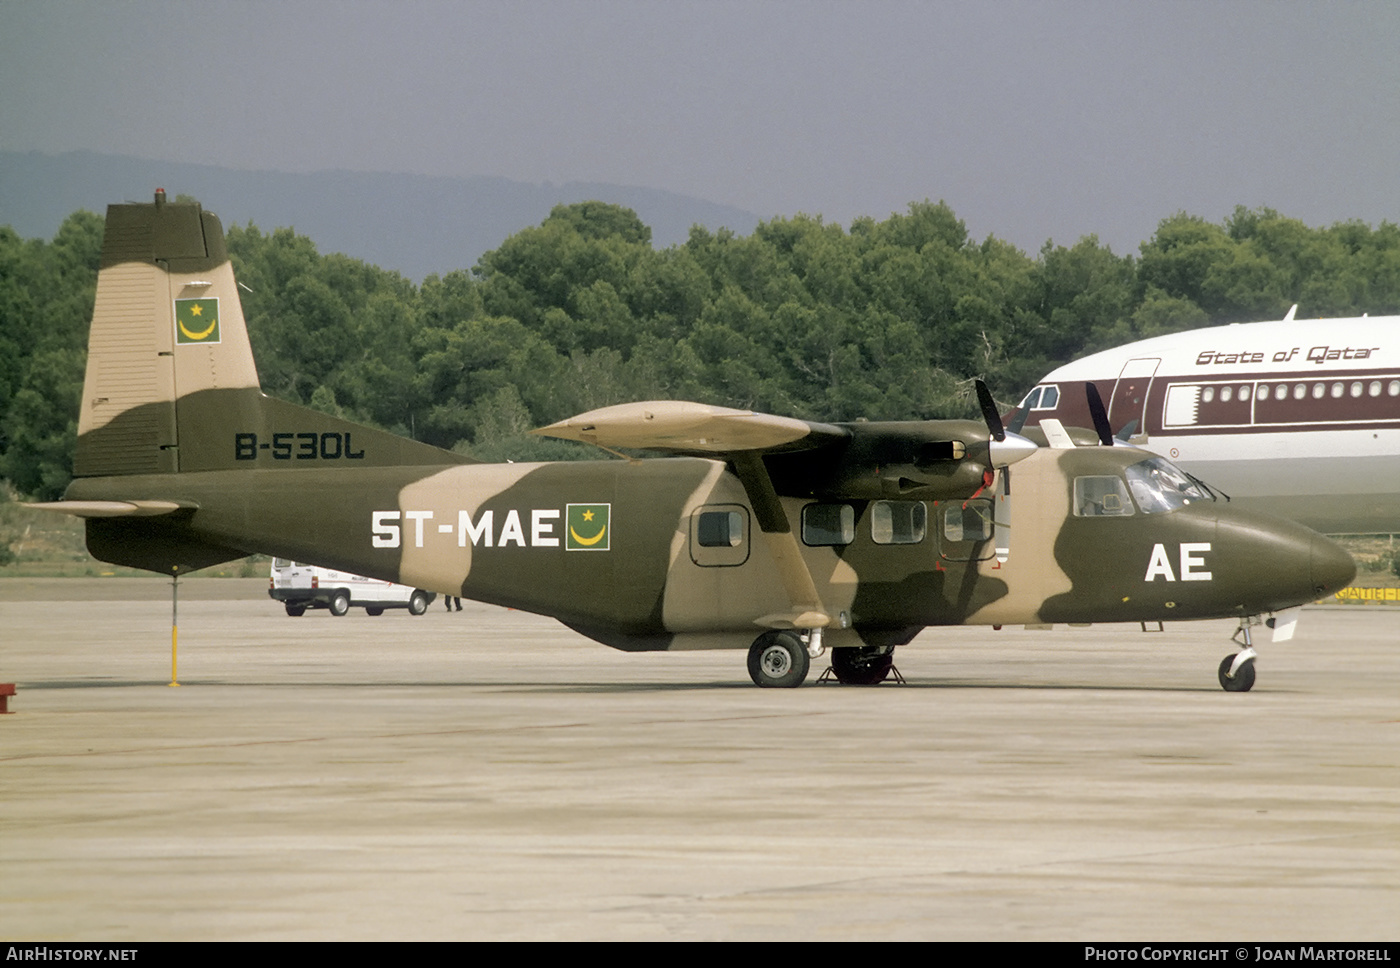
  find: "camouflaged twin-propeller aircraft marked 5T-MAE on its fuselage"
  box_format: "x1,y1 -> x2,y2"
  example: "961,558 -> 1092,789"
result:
27,192 -> 1354,691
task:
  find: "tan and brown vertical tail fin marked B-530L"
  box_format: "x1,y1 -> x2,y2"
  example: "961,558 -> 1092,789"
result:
73,191 -> 468,478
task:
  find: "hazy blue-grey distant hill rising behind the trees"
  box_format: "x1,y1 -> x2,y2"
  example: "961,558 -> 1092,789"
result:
0,151 -> 759,282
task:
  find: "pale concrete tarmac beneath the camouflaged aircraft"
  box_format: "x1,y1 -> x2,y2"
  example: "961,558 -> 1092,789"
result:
0,579 -> 1400,943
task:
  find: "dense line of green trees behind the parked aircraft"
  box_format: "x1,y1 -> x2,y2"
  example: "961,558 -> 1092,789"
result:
0,202 -> 1400,499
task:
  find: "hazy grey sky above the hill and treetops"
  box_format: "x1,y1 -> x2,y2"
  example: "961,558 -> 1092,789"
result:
0,0 -> 1400,252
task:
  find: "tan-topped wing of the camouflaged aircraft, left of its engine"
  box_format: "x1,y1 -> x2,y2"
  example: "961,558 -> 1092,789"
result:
531,401 -> 850,454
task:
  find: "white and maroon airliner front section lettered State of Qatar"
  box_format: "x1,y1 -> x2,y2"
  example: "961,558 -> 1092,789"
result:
1011,307 -> 1400,534
